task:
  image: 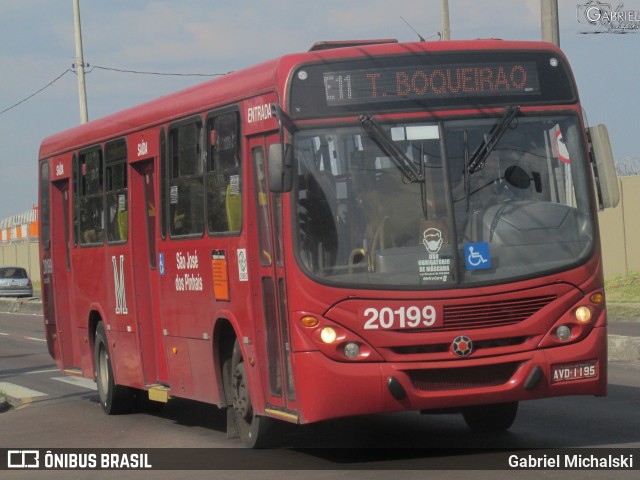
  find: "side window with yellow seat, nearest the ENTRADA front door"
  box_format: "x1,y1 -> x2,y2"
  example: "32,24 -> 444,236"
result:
206,111 -> 242,233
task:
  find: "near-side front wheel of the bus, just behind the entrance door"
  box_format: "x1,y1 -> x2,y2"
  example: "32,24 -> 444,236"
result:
222,340 -> 271,448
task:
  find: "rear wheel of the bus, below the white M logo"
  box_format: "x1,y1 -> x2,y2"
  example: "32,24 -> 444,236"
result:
94,322 -> 133,415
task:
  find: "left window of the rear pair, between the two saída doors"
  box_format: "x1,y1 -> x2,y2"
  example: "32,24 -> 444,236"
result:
78,148 -> 104,245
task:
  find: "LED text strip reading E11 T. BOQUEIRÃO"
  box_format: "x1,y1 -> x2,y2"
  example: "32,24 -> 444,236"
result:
323,62 -> 540,106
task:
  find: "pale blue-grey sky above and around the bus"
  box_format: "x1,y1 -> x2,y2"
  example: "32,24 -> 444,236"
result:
0,0 -> 640,219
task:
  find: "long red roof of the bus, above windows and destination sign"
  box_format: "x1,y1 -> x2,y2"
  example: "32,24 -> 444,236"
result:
39,39 -> 562,159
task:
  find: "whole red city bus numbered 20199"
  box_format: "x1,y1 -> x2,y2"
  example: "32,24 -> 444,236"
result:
39,40 -> 618,446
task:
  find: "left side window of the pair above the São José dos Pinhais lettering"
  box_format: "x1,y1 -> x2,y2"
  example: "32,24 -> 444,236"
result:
169,120 -> 204,236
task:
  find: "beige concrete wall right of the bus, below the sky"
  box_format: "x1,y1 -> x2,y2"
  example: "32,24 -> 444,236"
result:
598,175 -> 640,278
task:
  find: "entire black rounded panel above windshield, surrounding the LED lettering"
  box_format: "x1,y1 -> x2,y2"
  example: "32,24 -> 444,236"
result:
289,51 -> 578,118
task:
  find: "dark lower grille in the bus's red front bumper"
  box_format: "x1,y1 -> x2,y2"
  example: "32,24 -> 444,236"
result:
407,362 -> 520,392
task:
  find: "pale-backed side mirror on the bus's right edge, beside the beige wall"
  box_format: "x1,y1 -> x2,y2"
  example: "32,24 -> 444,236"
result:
589,125 -> 620,208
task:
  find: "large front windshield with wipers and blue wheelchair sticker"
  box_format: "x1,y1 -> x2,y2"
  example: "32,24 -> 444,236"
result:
294,112 -> 595,289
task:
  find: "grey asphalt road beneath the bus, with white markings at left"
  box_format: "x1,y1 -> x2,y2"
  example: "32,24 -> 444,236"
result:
0,313 -> 640,480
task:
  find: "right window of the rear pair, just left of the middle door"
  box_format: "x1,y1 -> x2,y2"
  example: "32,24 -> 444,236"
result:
105,140 -> 129,243
